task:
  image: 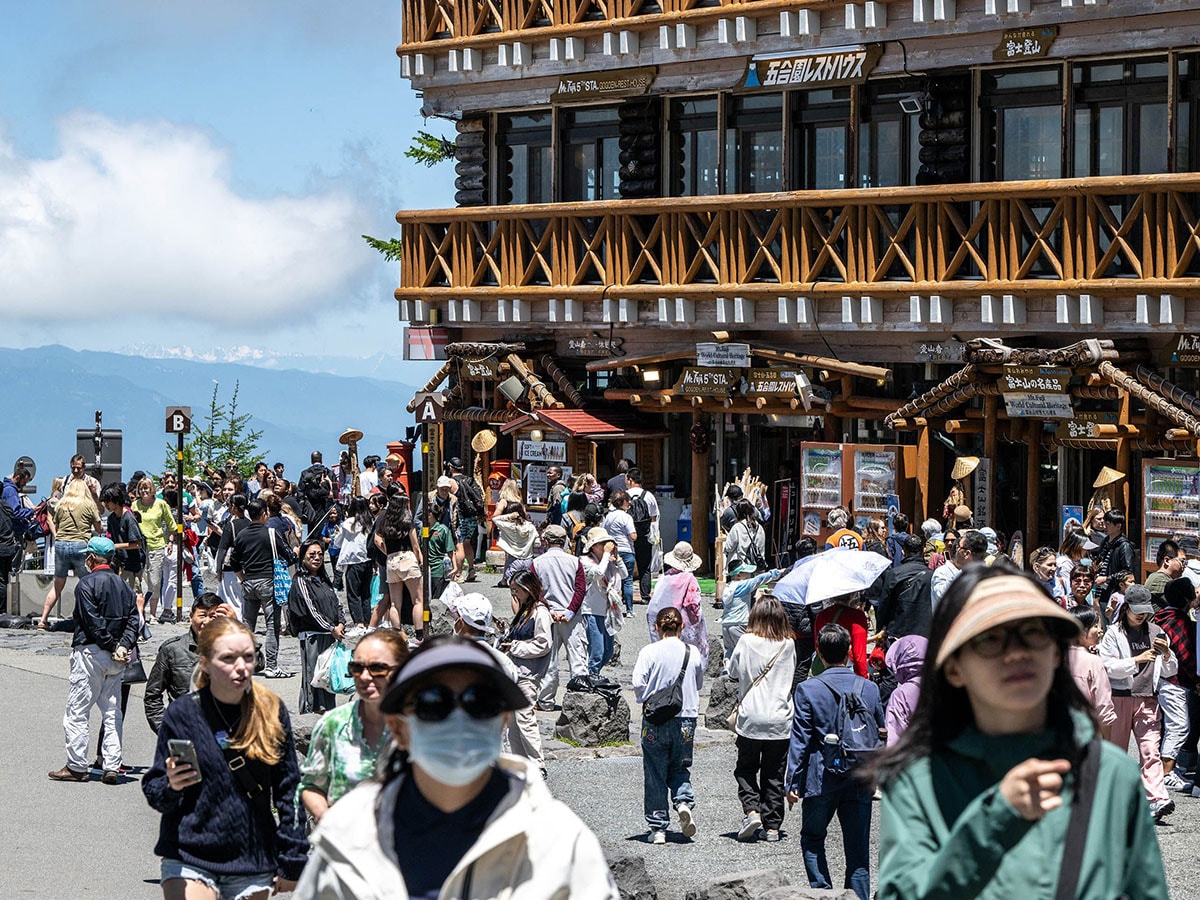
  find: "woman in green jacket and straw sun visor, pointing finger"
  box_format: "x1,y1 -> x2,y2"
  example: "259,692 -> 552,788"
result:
874,565 -> 1168,900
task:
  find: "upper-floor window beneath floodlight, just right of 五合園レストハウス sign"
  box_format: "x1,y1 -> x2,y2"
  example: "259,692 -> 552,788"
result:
857,83 -> 920,187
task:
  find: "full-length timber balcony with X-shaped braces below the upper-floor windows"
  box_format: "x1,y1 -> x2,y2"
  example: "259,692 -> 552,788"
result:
396,173 -> 1200,301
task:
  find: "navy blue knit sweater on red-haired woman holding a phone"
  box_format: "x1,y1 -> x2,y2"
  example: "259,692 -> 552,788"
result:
142,688 -> 308,881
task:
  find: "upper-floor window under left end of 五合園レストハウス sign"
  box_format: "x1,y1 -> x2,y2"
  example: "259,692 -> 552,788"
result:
725,94 -> 784,193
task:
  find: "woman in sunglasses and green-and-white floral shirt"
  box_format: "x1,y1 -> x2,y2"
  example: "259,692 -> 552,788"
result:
299,629 -> 408,822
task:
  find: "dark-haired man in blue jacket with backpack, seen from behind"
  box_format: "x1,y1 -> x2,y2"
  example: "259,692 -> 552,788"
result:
786,625 -> 884,900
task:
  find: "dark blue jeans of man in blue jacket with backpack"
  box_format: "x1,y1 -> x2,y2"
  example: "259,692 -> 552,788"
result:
800,782 -> 871,900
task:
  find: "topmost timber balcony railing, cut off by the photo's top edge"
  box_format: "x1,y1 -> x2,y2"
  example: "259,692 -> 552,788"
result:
398,0 -> 818,53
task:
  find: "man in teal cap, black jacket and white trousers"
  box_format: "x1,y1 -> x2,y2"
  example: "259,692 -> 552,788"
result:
49,538 -> 139,785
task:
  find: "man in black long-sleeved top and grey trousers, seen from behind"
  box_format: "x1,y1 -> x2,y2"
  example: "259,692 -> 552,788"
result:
229,497 -> 295,678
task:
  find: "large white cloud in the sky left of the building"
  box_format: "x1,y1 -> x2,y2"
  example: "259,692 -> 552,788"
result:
0,113 -> 377,324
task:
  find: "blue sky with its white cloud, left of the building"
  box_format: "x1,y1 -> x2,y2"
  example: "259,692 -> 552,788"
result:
0,0 -> 454,374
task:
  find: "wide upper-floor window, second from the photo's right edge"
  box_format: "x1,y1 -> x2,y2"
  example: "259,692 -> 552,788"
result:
1072,58 -> 1168,178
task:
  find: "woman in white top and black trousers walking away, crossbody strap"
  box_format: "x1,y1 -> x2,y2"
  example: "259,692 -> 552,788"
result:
728,596 -> 796,841
